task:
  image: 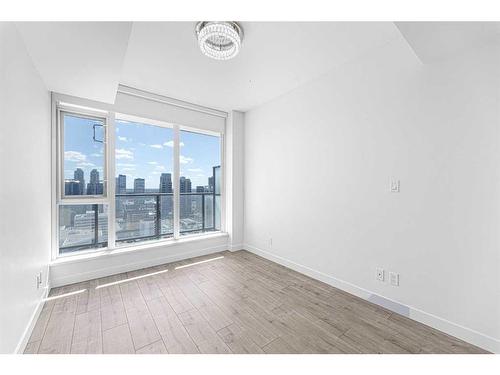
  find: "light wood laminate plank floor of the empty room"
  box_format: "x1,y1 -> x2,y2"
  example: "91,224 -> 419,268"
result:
25,251 -> 485,354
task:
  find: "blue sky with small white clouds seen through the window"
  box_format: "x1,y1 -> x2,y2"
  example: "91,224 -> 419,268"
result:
64,117 -> 220,190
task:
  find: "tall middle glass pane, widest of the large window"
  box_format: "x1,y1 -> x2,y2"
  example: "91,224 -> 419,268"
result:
115,120 -> 174,242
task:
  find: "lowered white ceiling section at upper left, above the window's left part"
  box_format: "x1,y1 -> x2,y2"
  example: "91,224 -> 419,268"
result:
16,22 -> 132,103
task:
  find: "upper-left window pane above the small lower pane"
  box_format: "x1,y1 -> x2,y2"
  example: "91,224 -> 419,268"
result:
62,112 -> 106,196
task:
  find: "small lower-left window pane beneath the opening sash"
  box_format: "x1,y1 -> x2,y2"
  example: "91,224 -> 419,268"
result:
59,204 -> 108,254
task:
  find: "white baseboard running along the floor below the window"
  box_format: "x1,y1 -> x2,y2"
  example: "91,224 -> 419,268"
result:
51,245 -> 228,287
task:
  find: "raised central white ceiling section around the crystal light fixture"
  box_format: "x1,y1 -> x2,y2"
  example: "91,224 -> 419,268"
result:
121,22 -> 398,111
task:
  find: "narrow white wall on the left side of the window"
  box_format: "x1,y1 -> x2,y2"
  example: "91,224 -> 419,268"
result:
0,22 -> 51,353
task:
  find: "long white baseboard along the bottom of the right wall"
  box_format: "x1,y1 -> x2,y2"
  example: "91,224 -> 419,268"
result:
243,244 -> 500,353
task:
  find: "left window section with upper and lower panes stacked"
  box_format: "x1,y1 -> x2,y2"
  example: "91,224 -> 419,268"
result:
58,110 -> 108,254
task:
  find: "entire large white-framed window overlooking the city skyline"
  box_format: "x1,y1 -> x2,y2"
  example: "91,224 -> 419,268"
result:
56,107 -> 222,255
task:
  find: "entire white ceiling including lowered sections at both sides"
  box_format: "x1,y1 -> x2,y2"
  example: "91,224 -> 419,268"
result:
13,22 -> 500,111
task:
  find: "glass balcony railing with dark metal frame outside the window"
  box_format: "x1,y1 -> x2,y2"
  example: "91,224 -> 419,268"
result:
59,192 -> 220,254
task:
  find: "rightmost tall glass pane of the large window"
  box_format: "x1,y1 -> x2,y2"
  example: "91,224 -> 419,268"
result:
179,130 -> 221,235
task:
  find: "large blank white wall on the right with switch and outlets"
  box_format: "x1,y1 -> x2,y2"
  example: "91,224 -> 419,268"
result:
244,33 -> 500,351
